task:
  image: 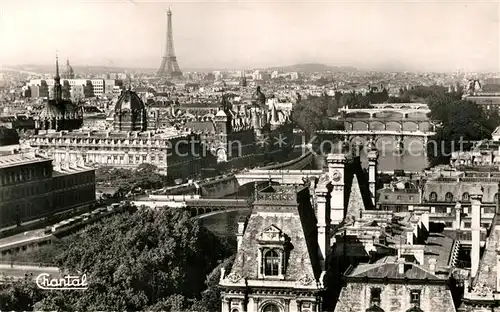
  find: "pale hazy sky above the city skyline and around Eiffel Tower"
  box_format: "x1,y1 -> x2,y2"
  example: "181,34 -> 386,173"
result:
0,0 -> 500,71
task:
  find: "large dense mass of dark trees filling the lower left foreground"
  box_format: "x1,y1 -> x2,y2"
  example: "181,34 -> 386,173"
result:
0,208 -> 235,311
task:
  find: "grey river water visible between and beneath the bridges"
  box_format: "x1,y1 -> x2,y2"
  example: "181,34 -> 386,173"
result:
202,114 -> 431,237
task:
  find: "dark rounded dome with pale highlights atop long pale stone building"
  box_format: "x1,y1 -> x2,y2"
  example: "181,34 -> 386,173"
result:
114,87 -> 147,131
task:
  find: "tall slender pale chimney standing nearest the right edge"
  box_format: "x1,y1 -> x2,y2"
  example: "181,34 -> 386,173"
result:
469,187 -> 483,278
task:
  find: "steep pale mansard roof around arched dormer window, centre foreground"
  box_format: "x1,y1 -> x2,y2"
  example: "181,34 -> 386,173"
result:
226,186 -> 321,284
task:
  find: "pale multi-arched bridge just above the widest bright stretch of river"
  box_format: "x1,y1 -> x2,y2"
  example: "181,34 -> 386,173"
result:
341,117 -> 436,132
